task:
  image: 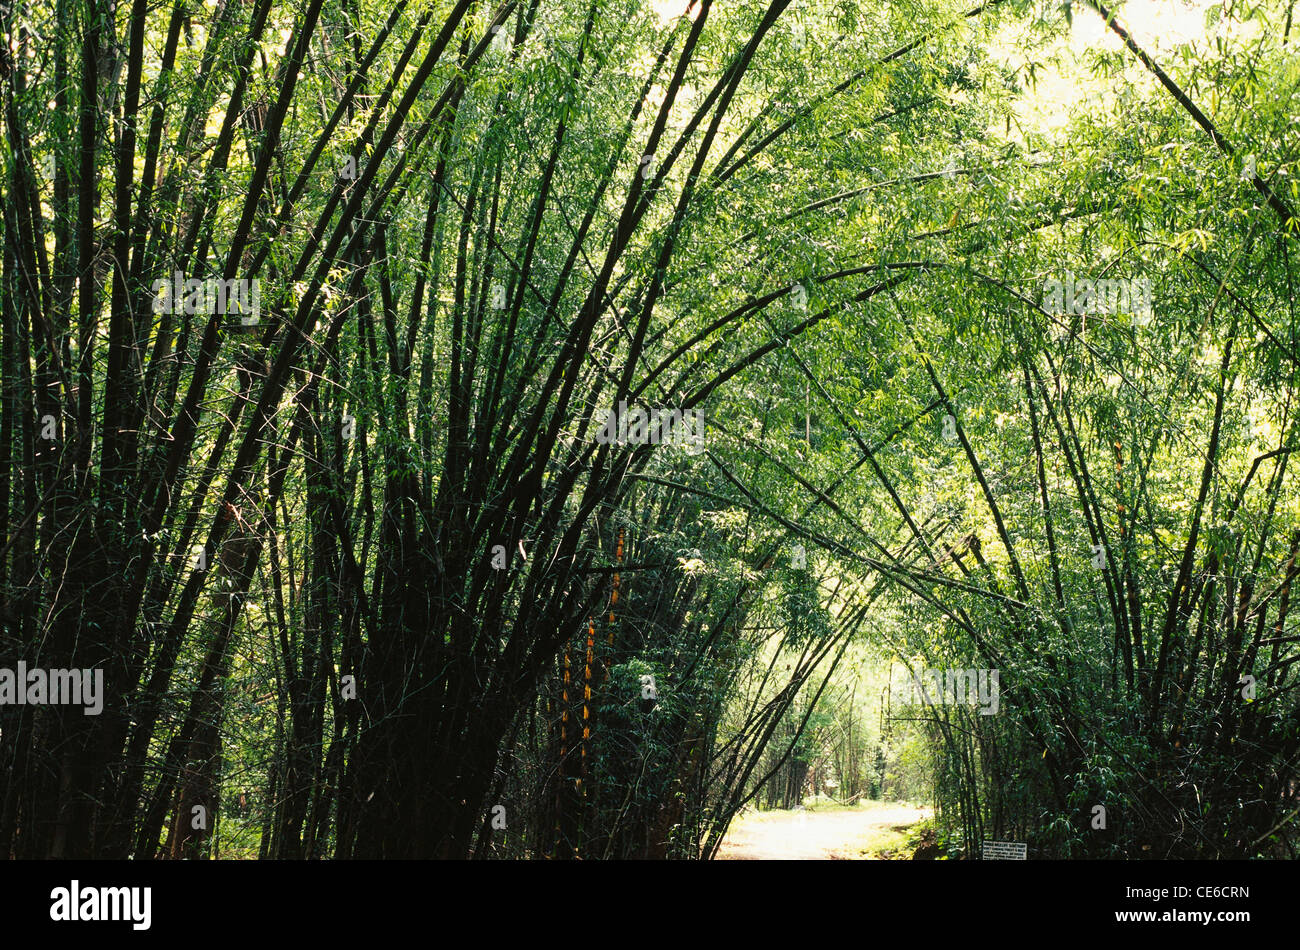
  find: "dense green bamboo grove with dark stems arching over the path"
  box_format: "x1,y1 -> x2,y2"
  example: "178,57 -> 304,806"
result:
0,0 -> 1300,859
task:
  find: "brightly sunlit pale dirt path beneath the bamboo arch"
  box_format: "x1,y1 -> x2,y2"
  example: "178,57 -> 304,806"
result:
718,802 -> 933,860
